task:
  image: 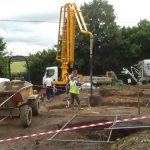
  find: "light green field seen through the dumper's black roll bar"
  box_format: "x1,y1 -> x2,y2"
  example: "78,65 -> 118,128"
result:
10,61 -> 27,74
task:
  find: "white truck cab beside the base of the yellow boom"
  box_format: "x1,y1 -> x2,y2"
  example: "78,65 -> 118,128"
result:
43,66 -> 58,84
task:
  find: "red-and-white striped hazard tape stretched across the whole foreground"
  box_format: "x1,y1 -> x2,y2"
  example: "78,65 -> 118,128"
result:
0,115 -> 150,143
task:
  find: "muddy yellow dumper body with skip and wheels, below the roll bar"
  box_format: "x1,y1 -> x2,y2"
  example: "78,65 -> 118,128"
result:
0,80 -> 40,127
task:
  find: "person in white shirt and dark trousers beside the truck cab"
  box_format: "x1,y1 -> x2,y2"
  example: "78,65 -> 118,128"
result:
44,75 -> 53,100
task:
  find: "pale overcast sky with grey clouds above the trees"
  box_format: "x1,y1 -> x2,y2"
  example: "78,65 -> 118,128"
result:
0,0 -> 150,55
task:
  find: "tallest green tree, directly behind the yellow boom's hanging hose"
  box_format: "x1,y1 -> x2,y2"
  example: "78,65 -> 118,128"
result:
75,0 -> 118,75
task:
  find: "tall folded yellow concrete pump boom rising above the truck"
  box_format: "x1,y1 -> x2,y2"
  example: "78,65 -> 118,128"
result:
54,3 -> 93,85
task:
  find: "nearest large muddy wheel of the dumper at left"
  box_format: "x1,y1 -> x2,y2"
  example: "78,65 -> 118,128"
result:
20,105 -> 32,127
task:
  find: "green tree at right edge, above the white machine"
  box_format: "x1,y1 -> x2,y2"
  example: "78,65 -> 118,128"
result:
114,20 -> 150,68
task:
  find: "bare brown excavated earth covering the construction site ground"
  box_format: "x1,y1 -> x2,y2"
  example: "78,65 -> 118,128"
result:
0,85 -> 150,150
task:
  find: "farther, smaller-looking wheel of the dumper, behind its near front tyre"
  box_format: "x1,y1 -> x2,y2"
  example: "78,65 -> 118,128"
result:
30,99 -> 40,116
